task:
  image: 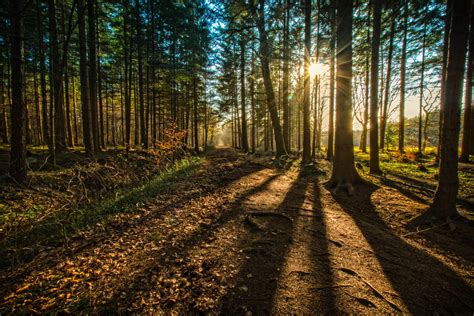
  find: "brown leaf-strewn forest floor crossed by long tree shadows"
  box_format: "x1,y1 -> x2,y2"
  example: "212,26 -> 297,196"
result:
0,148 -> 474,315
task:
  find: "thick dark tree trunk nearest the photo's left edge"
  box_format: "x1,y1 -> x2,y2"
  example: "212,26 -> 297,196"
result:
9,0 -> 26,183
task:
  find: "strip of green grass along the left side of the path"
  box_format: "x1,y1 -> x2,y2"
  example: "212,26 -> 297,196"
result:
0,157 -> 204,267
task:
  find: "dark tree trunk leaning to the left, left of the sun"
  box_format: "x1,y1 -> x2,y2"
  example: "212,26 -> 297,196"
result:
252,0 -> 287,159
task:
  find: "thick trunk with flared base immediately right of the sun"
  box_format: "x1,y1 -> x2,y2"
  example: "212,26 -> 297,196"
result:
328,0 -> 361,194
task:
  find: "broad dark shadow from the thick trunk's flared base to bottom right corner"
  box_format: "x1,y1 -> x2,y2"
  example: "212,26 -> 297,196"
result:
333,184 -> 474,314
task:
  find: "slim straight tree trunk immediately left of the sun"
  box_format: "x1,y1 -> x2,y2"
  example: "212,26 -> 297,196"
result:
302,0 -> 311,164
